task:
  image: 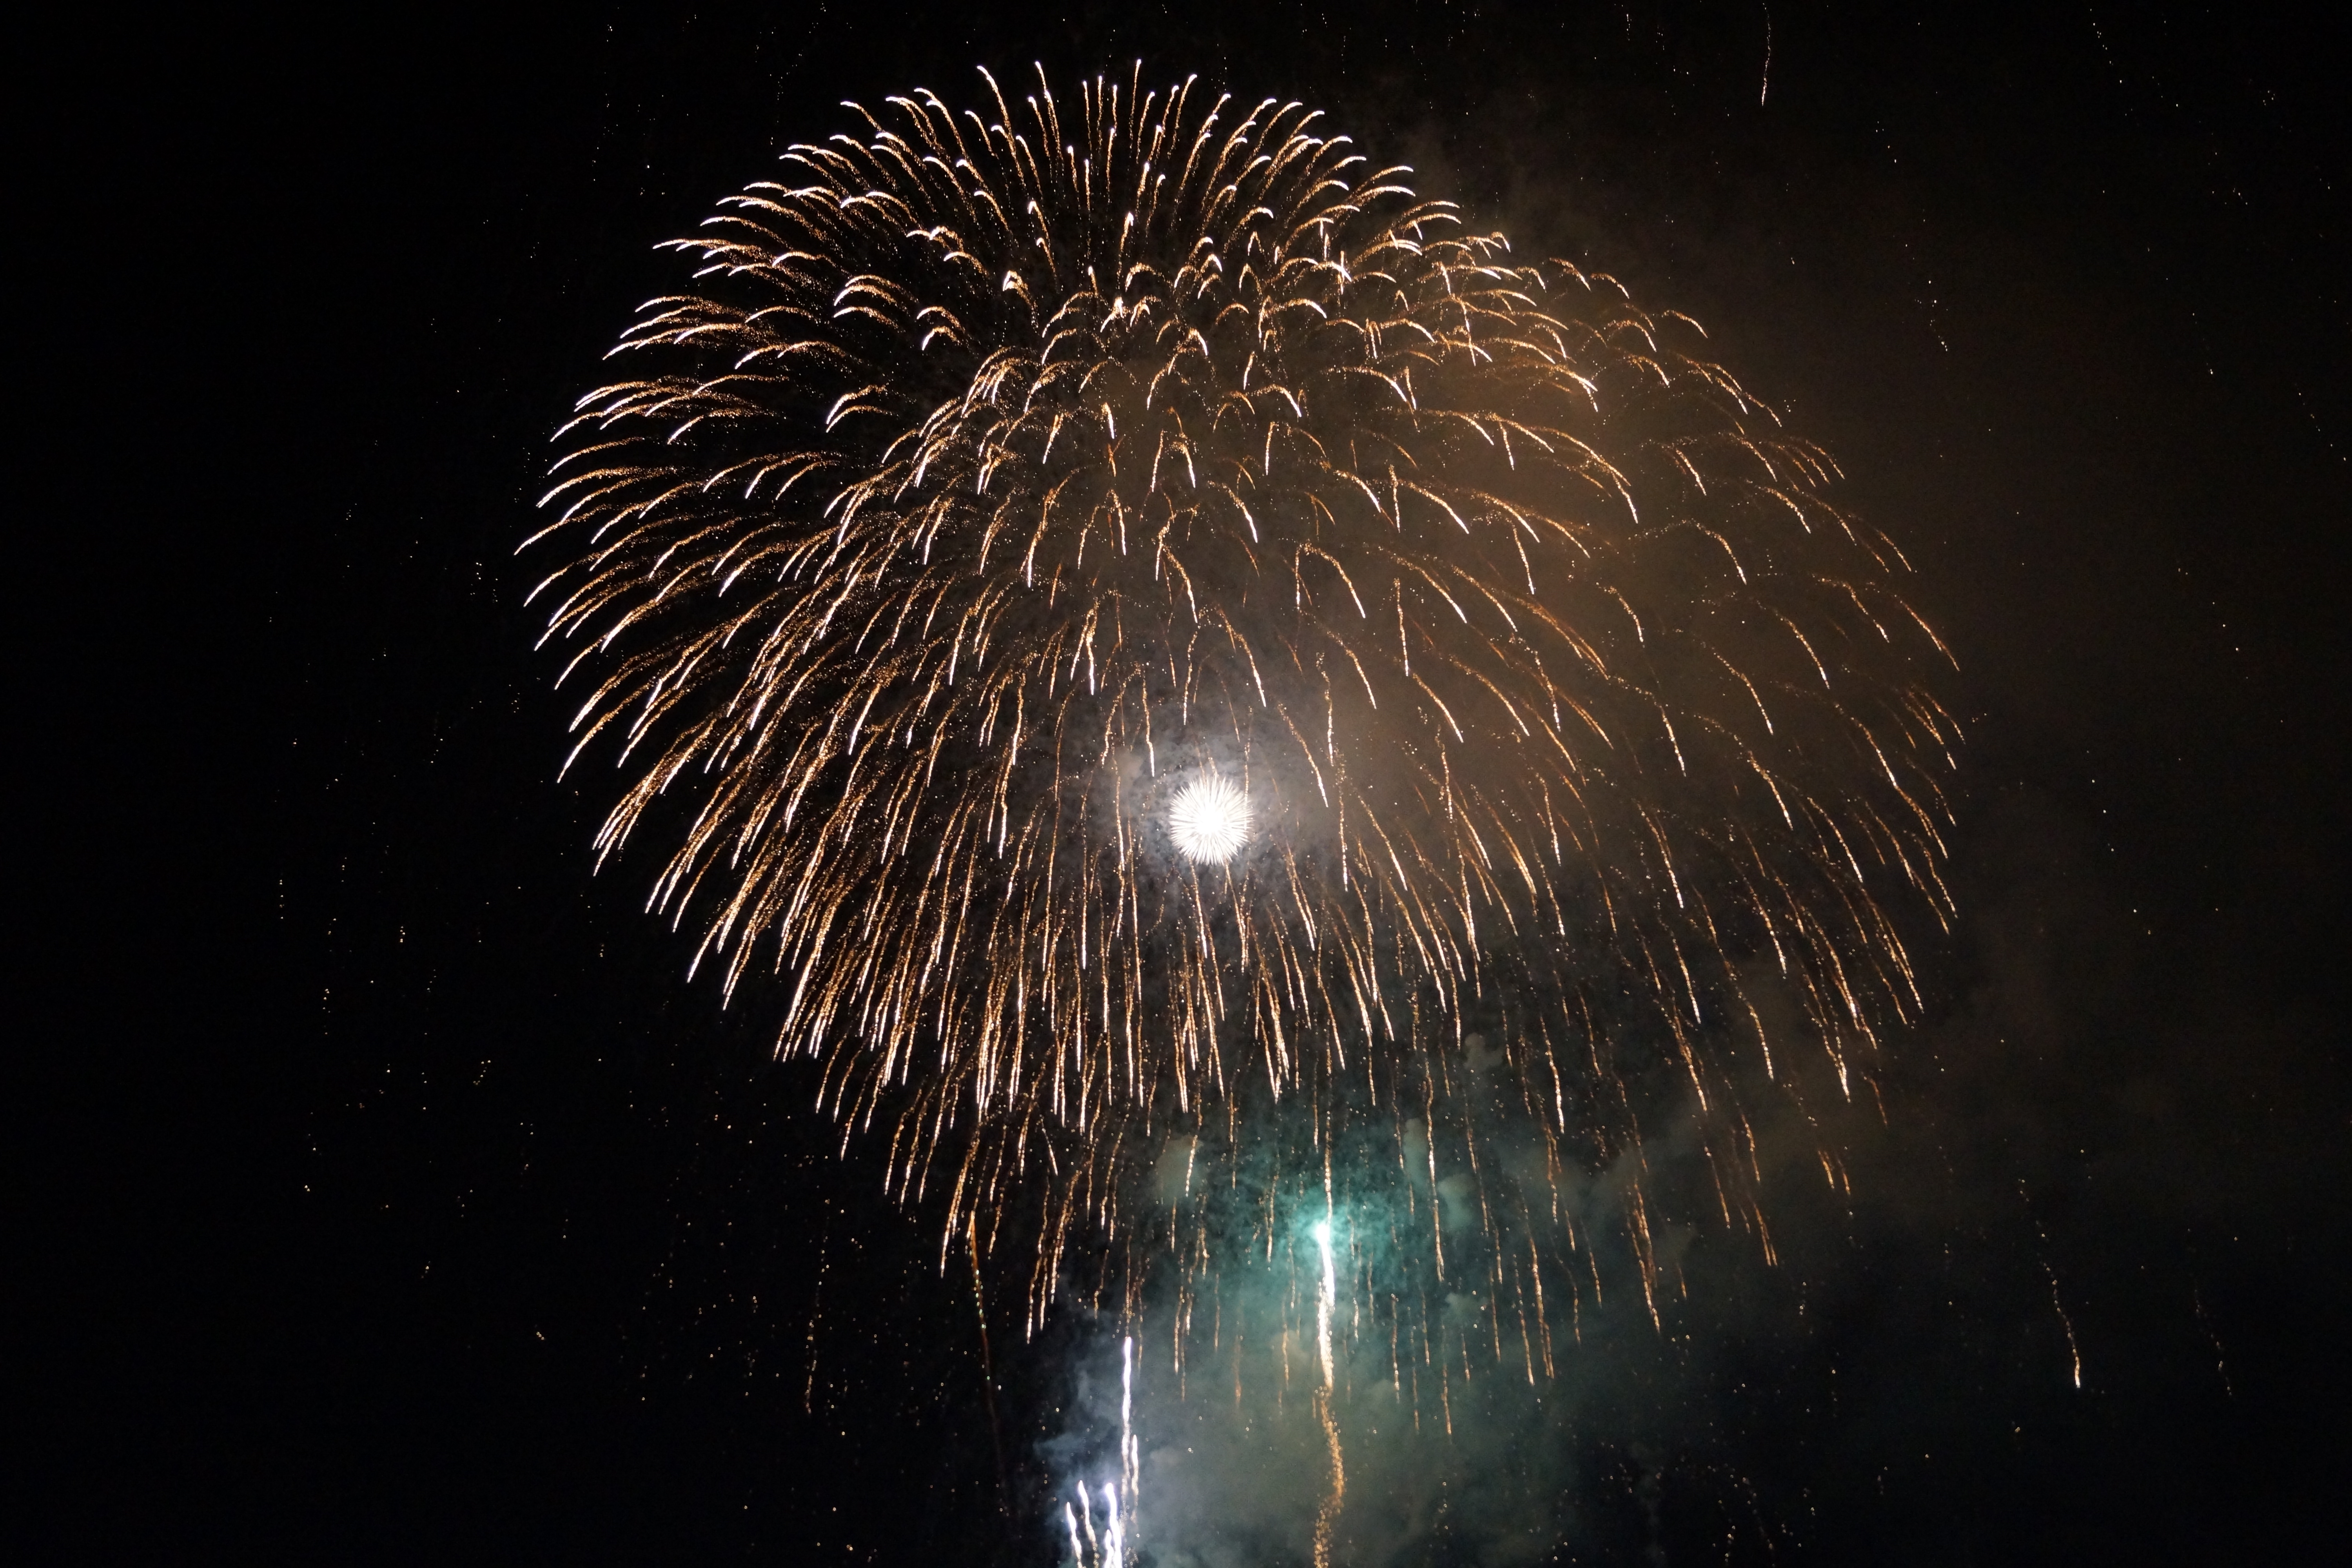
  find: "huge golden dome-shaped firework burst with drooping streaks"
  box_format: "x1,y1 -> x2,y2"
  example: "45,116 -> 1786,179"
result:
527,71 -> 1957,1321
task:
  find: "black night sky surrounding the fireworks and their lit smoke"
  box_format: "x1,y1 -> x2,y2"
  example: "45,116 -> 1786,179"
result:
23,0 -> 2352,1563
